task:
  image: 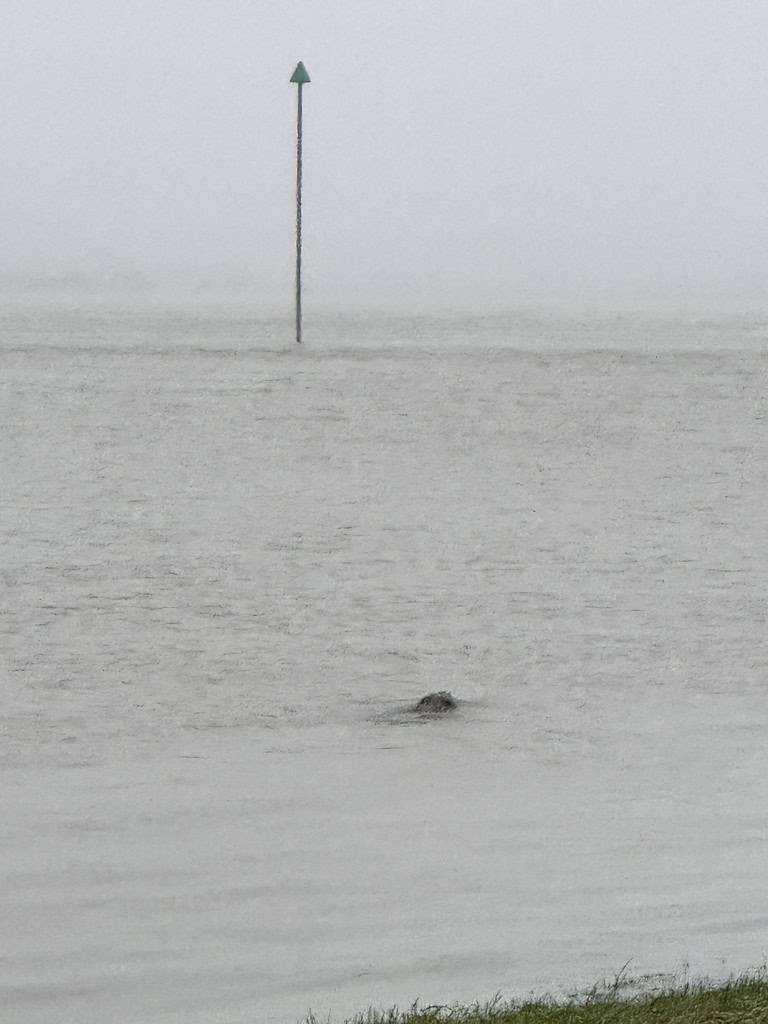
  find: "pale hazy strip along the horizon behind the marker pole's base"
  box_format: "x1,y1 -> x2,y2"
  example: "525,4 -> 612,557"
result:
0,292 -> 768,355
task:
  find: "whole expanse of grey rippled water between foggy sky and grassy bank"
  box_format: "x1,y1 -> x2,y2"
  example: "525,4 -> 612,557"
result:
0,308 -> 768,1024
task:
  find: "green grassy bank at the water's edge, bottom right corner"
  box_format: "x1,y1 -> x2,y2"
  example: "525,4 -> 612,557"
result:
306,970 -> 768,1024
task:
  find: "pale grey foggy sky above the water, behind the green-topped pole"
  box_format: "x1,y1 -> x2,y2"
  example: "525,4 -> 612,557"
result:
0,0 -> 768,307
